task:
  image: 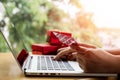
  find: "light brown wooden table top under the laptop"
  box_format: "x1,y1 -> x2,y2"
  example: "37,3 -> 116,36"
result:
0,53 -> 116,80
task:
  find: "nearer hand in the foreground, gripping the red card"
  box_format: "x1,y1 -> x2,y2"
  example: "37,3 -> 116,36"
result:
71,46 -> 120,73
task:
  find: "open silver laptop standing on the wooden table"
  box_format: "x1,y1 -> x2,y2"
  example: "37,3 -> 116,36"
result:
0,24 -> 117,76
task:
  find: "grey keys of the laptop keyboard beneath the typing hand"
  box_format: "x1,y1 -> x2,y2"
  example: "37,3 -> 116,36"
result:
37,56 -> 74,71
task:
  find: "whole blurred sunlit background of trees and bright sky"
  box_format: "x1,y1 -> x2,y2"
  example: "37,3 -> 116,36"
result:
0,0 -> 120,52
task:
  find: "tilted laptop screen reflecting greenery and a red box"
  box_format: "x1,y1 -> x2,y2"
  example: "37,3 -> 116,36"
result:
0,23 -> 27,65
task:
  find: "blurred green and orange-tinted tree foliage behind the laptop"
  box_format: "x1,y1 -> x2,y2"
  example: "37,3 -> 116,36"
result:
0,0 -> 101,51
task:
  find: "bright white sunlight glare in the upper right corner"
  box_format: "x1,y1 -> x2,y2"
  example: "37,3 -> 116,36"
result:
80,0 -> 120,28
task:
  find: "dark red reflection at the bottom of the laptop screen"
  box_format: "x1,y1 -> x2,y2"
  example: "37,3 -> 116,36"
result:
17,49 -> 28,66
